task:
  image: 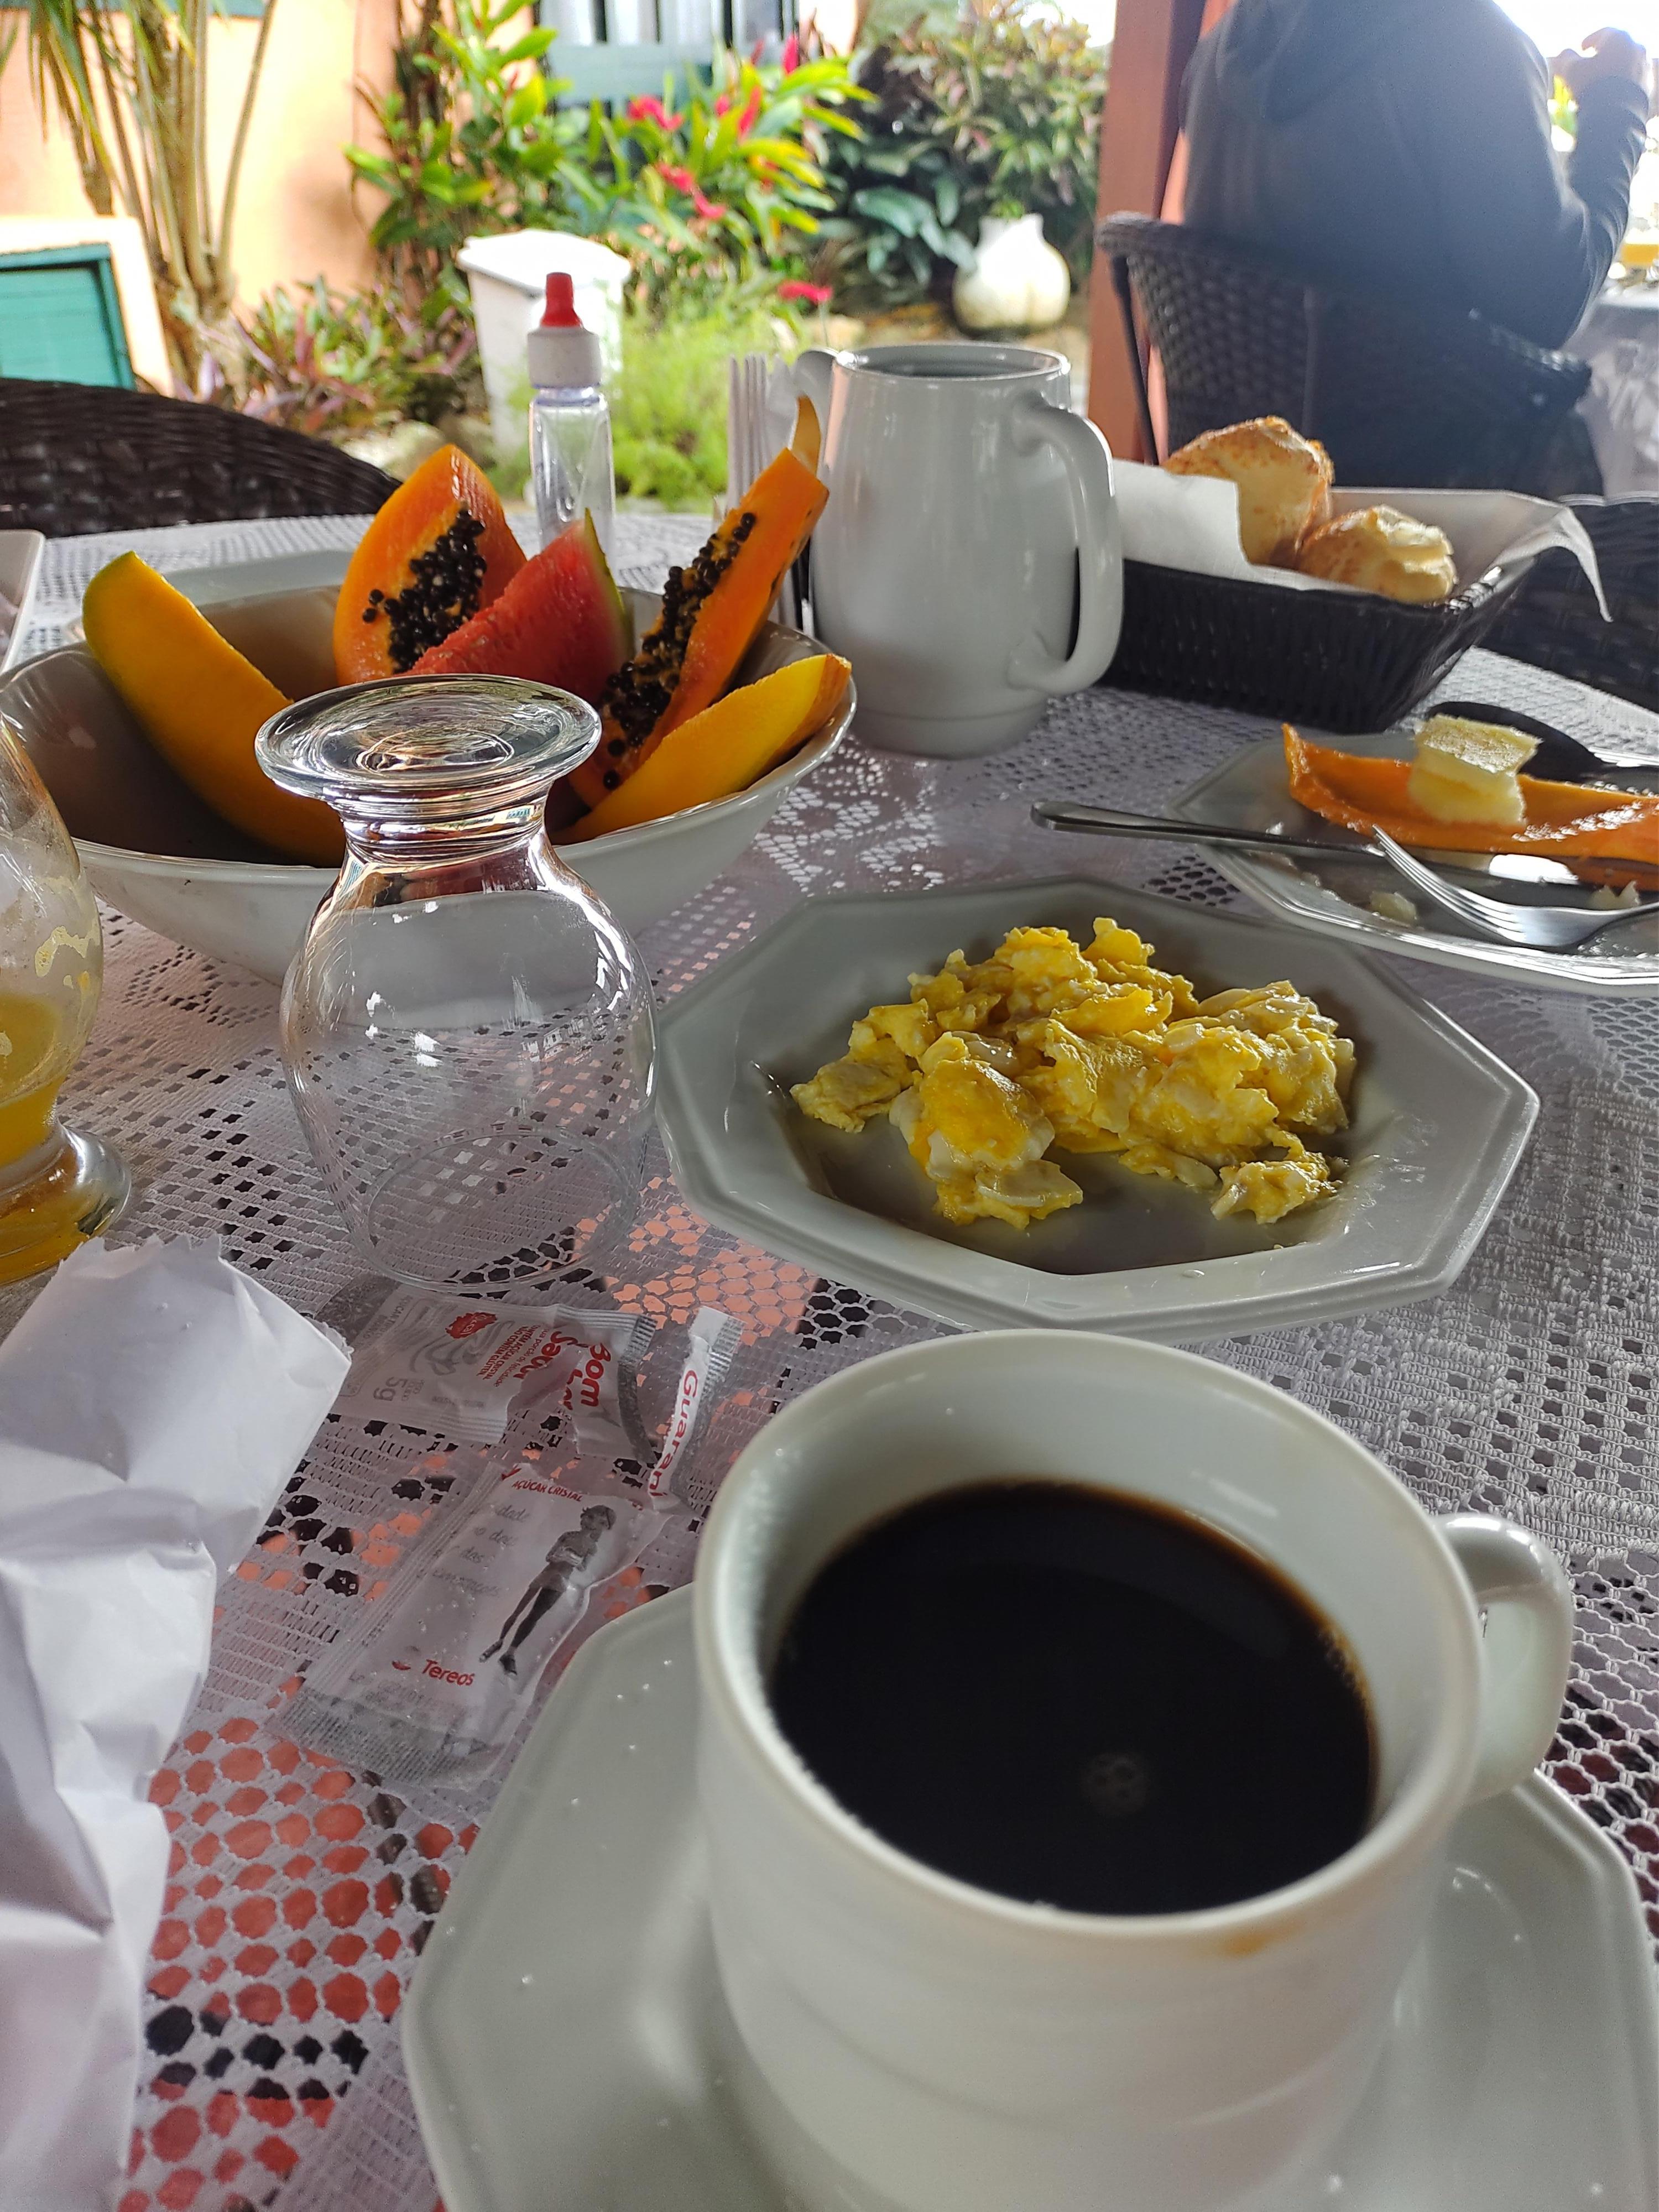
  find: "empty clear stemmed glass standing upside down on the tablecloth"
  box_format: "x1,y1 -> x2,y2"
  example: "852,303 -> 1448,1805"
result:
259,677 -> 653,1296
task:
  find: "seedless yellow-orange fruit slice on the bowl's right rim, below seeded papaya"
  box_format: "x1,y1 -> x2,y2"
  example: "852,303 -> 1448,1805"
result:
568,653 -> 852,843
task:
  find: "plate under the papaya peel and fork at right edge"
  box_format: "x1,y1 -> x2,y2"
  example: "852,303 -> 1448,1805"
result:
1170,723 -> 1659,998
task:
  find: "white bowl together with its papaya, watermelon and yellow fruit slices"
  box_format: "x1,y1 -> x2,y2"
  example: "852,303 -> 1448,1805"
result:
0,416 -> 856,980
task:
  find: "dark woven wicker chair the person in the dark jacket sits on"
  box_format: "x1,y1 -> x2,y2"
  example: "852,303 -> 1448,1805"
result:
1097,215 -> 1599,491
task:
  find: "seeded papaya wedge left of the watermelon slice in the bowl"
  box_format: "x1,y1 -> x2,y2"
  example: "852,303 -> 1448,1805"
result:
334,445 -> 524,684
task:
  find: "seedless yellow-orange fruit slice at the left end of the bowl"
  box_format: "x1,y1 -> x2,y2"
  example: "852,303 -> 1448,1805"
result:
82,553 -> 345,867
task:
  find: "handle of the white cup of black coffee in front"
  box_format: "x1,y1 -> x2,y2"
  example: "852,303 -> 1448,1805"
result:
1438,1513 -> 1573,1805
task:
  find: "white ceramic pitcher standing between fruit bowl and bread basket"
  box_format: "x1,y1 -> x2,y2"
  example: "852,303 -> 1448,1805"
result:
796,345 -> 1124,757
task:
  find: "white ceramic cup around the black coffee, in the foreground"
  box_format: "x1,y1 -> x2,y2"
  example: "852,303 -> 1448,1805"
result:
695,1329 -> 1571,2212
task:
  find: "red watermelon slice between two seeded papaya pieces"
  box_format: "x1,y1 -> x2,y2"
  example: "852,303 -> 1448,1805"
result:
409,515 -> 633,706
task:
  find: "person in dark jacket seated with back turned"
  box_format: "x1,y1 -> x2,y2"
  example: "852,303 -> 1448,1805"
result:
1183,0 -> 1648,345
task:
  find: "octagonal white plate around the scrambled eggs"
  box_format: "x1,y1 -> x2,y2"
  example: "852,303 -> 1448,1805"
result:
657,876 -> 1537,1343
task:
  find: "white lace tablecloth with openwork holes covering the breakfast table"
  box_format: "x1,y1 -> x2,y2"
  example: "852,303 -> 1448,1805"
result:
16,518 -> 1659,2212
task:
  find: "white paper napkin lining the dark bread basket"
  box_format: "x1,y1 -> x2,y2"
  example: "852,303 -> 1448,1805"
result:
1113,460 -> 1608,615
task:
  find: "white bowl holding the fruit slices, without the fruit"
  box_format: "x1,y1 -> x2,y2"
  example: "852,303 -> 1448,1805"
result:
0,577 -> 856,982
